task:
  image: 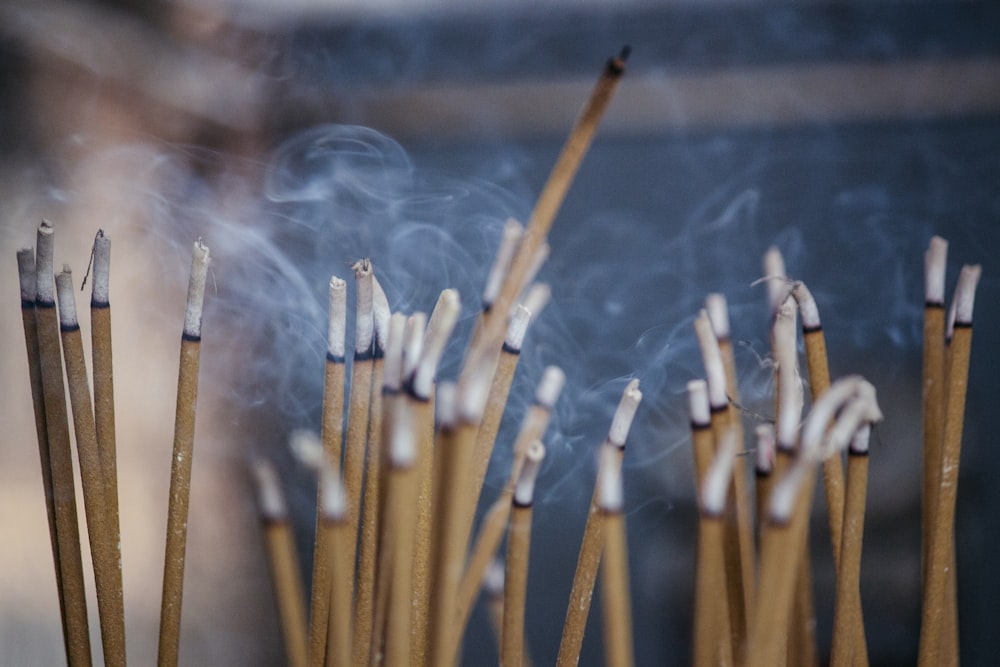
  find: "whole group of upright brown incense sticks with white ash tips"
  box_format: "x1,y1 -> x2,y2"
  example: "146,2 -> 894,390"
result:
18,44 -> 980,666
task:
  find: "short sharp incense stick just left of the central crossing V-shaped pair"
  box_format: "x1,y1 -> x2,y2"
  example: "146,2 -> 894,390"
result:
500,440 -> 545,667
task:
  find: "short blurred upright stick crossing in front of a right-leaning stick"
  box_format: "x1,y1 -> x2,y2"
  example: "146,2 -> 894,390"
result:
597,449 -> 635,667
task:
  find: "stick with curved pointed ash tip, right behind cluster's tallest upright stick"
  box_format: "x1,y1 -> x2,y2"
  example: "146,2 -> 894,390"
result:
354,274 -> 391,665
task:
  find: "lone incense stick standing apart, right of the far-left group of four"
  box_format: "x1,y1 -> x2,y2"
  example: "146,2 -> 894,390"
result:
157,239 -> 209,667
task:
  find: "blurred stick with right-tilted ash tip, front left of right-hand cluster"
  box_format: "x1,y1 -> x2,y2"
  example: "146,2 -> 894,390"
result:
694,425 -> 738,667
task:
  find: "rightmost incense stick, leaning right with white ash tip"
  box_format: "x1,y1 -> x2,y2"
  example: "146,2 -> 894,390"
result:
919,265 -> 982,666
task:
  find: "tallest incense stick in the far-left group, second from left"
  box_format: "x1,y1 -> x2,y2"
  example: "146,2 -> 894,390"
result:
35,221 -> 91,665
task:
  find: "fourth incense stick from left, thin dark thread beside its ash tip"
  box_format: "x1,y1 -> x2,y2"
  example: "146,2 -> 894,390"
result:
90,230 -> 124,612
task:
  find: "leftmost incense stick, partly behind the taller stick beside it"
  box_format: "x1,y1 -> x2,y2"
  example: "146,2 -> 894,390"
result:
17,248 -> 70,661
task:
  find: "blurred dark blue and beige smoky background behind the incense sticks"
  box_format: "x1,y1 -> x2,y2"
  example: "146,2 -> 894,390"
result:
0,0 -> 1000,665
